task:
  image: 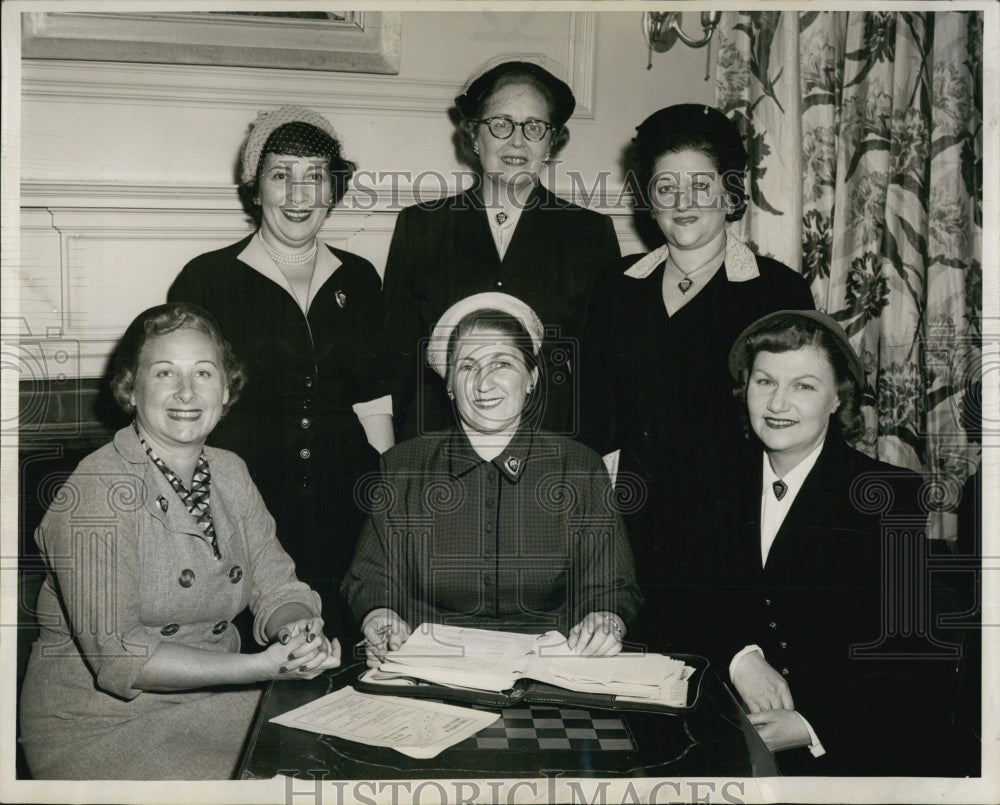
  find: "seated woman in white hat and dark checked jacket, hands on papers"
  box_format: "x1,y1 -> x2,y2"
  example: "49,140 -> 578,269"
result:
342,293 -> 641,663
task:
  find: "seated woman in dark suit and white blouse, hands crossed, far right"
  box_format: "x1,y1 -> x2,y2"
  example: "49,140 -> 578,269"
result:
706,310 -> 947,775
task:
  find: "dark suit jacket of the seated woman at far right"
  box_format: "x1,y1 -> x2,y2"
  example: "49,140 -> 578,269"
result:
701,436 -> 948,775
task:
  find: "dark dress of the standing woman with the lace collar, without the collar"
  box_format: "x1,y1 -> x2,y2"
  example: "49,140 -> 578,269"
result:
580,248 -> 813,652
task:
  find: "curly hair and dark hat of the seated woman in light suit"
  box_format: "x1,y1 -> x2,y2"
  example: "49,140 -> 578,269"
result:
111,302 -> 246,416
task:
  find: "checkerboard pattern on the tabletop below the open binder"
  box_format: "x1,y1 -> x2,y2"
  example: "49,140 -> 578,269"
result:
456,706 -> 636,752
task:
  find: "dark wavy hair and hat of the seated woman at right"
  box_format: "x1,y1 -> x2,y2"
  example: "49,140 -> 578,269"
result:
733,317 -> 864,442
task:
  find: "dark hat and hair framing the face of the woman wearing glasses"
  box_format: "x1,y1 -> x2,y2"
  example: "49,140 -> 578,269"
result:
455,61 -> 576,166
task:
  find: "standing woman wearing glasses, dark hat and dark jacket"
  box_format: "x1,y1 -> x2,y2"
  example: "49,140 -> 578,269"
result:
383,61 -> 620,439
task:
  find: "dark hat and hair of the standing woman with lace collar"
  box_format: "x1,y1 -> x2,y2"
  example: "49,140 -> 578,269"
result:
632,103 -> 747,221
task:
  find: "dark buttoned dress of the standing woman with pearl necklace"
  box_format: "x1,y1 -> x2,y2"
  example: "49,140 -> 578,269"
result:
167,236 -> 387,631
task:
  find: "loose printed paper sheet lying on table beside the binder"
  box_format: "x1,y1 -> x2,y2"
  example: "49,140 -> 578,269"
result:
271,685 -> 500,758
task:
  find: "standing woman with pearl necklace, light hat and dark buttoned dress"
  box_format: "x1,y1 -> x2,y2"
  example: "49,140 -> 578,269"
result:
168,106 -> 393,630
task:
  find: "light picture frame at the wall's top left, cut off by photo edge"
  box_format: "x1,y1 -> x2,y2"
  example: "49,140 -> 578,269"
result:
21,11 -> 401,75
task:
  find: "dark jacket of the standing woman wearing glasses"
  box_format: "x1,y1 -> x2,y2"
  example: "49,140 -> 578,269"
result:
383,185 -> 620,441
